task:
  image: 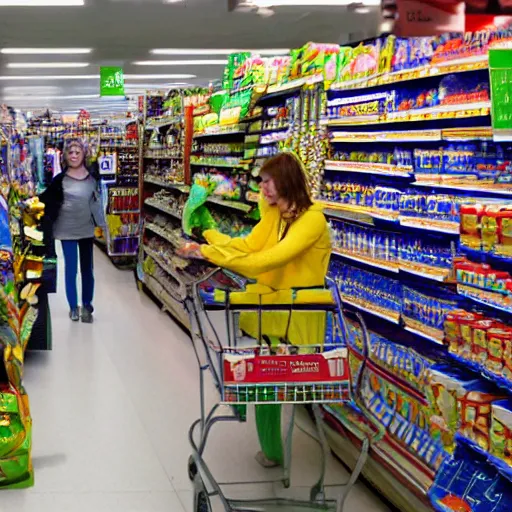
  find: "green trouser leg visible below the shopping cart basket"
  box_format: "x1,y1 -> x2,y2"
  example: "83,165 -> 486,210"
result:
256,404 -> 284,466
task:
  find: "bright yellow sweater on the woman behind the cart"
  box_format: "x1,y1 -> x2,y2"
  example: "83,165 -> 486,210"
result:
201,201 -> 331,344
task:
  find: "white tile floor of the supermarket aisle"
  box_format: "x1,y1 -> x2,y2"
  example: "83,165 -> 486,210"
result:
0,251 -> 389,512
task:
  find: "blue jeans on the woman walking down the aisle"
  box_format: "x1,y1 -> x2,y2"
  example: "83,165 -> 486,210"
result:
61,238 -> 94,309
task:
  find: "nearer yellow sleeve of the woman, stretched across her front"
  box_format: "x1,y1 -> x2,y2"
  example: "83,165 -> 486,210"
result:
201,212 -> 326,278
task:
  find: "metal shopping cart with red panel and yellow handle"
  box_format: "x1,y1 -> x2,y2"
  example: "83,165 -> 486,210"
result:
185,269 -> 380,512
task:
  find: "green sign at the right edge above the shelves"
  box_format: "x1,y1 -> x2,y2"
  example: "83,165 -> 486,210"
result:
489,48 -> 512,133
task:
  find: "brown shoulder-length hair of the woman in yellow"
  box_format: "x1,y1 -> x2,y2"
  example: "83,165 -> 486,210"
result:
260,153 -> 313,214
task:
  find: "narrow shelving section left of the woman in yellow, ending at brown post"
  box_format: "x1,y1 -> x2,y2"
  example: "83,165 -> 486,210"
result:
136,91 -> 198,328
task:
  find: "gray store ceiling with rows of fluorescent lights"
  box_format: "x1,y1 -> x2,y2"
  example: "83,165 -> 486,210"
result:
0,0 -> 379,114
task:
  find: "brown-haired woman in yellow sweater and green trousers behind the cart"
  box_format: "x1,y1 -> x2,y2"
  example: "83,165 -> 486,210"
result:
182,153 -> 331,466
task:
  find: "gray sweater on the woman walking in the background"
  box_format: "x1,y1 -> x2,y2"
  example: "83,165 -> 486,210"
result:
53,175 -> 105,240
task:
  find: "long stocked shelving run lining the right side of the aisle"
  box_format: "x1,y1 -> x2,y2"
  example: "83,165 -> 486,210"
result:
134,38 -> 512,512
